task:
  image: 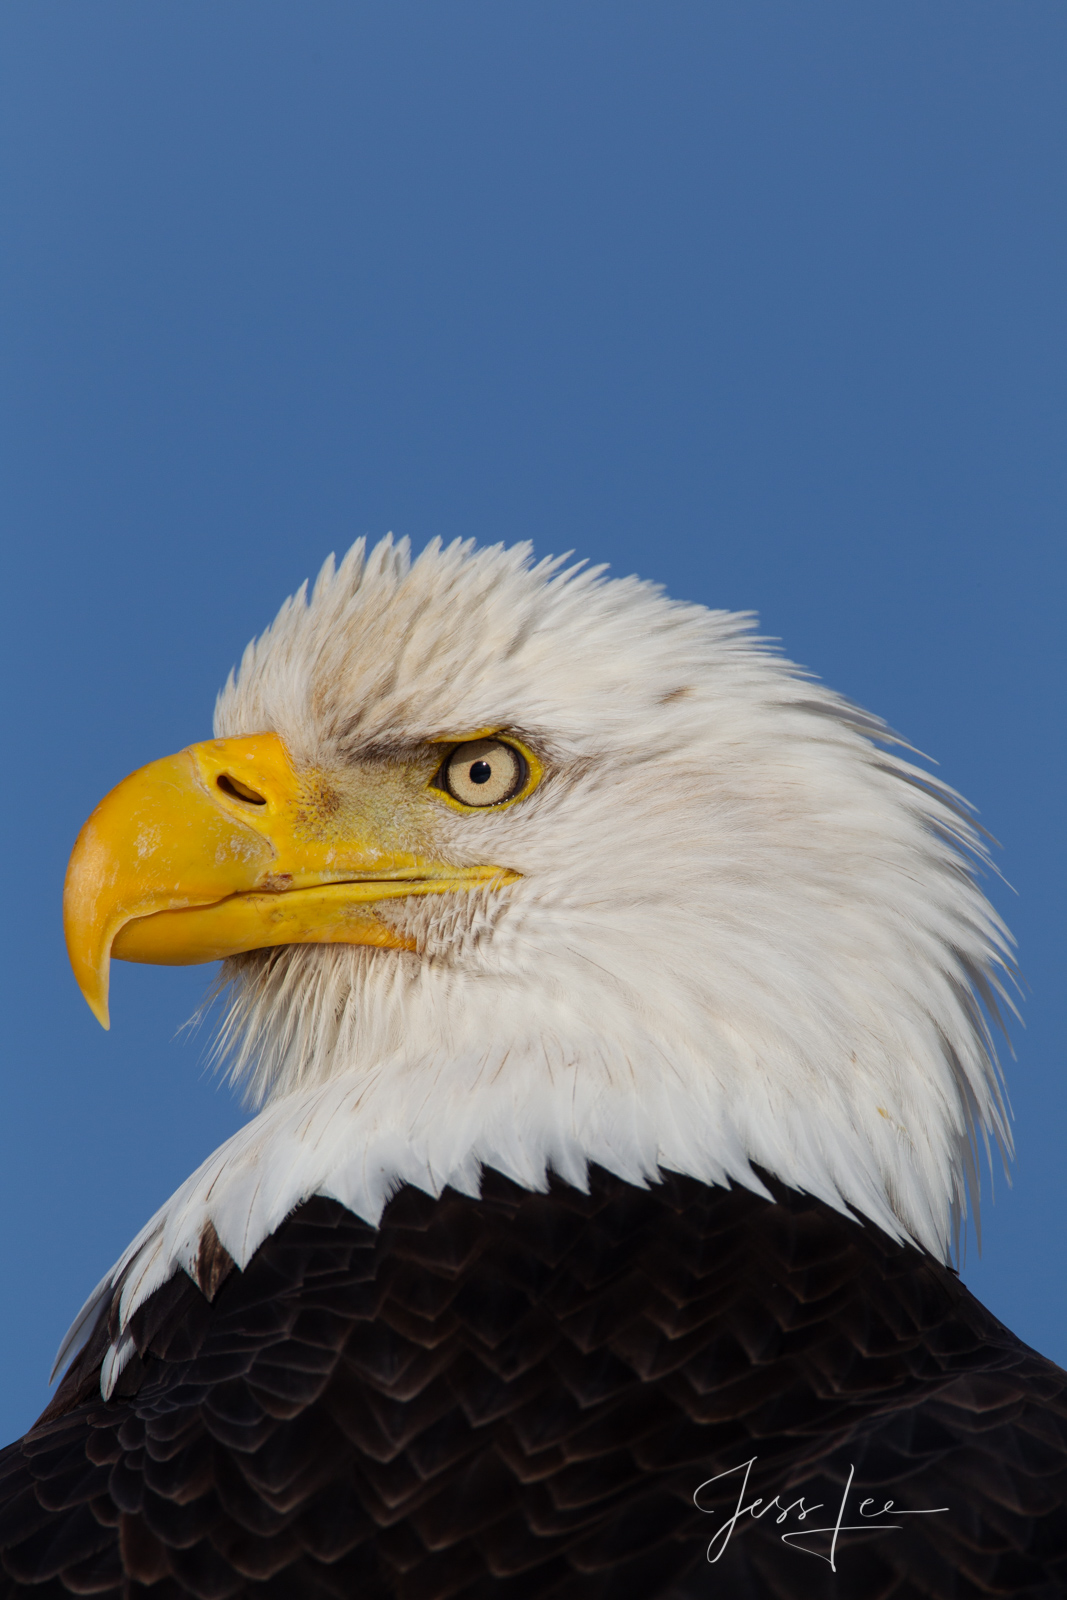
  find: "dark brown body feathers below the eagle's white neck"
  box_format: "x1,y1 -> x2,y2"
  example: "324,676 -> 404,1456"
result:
0,1171 -> 1067,1600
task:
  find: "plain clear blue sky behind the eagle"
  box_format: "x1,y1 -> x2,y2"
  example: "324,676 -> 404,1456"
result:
0,0 -> 1067,1437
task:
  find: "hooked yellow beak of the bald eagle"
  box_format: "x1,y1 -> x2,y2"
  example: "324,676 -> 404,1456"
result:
62,733 -> 518,1027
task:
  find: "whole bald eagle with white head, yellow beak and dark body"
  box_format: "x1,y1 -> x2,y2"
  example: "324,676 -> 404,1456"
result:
0,539 -> 1067,1600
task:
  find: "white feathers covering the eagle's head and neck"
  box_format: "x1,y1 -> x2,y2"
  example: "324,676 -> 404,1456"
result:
61,539 -> 1011,1390
